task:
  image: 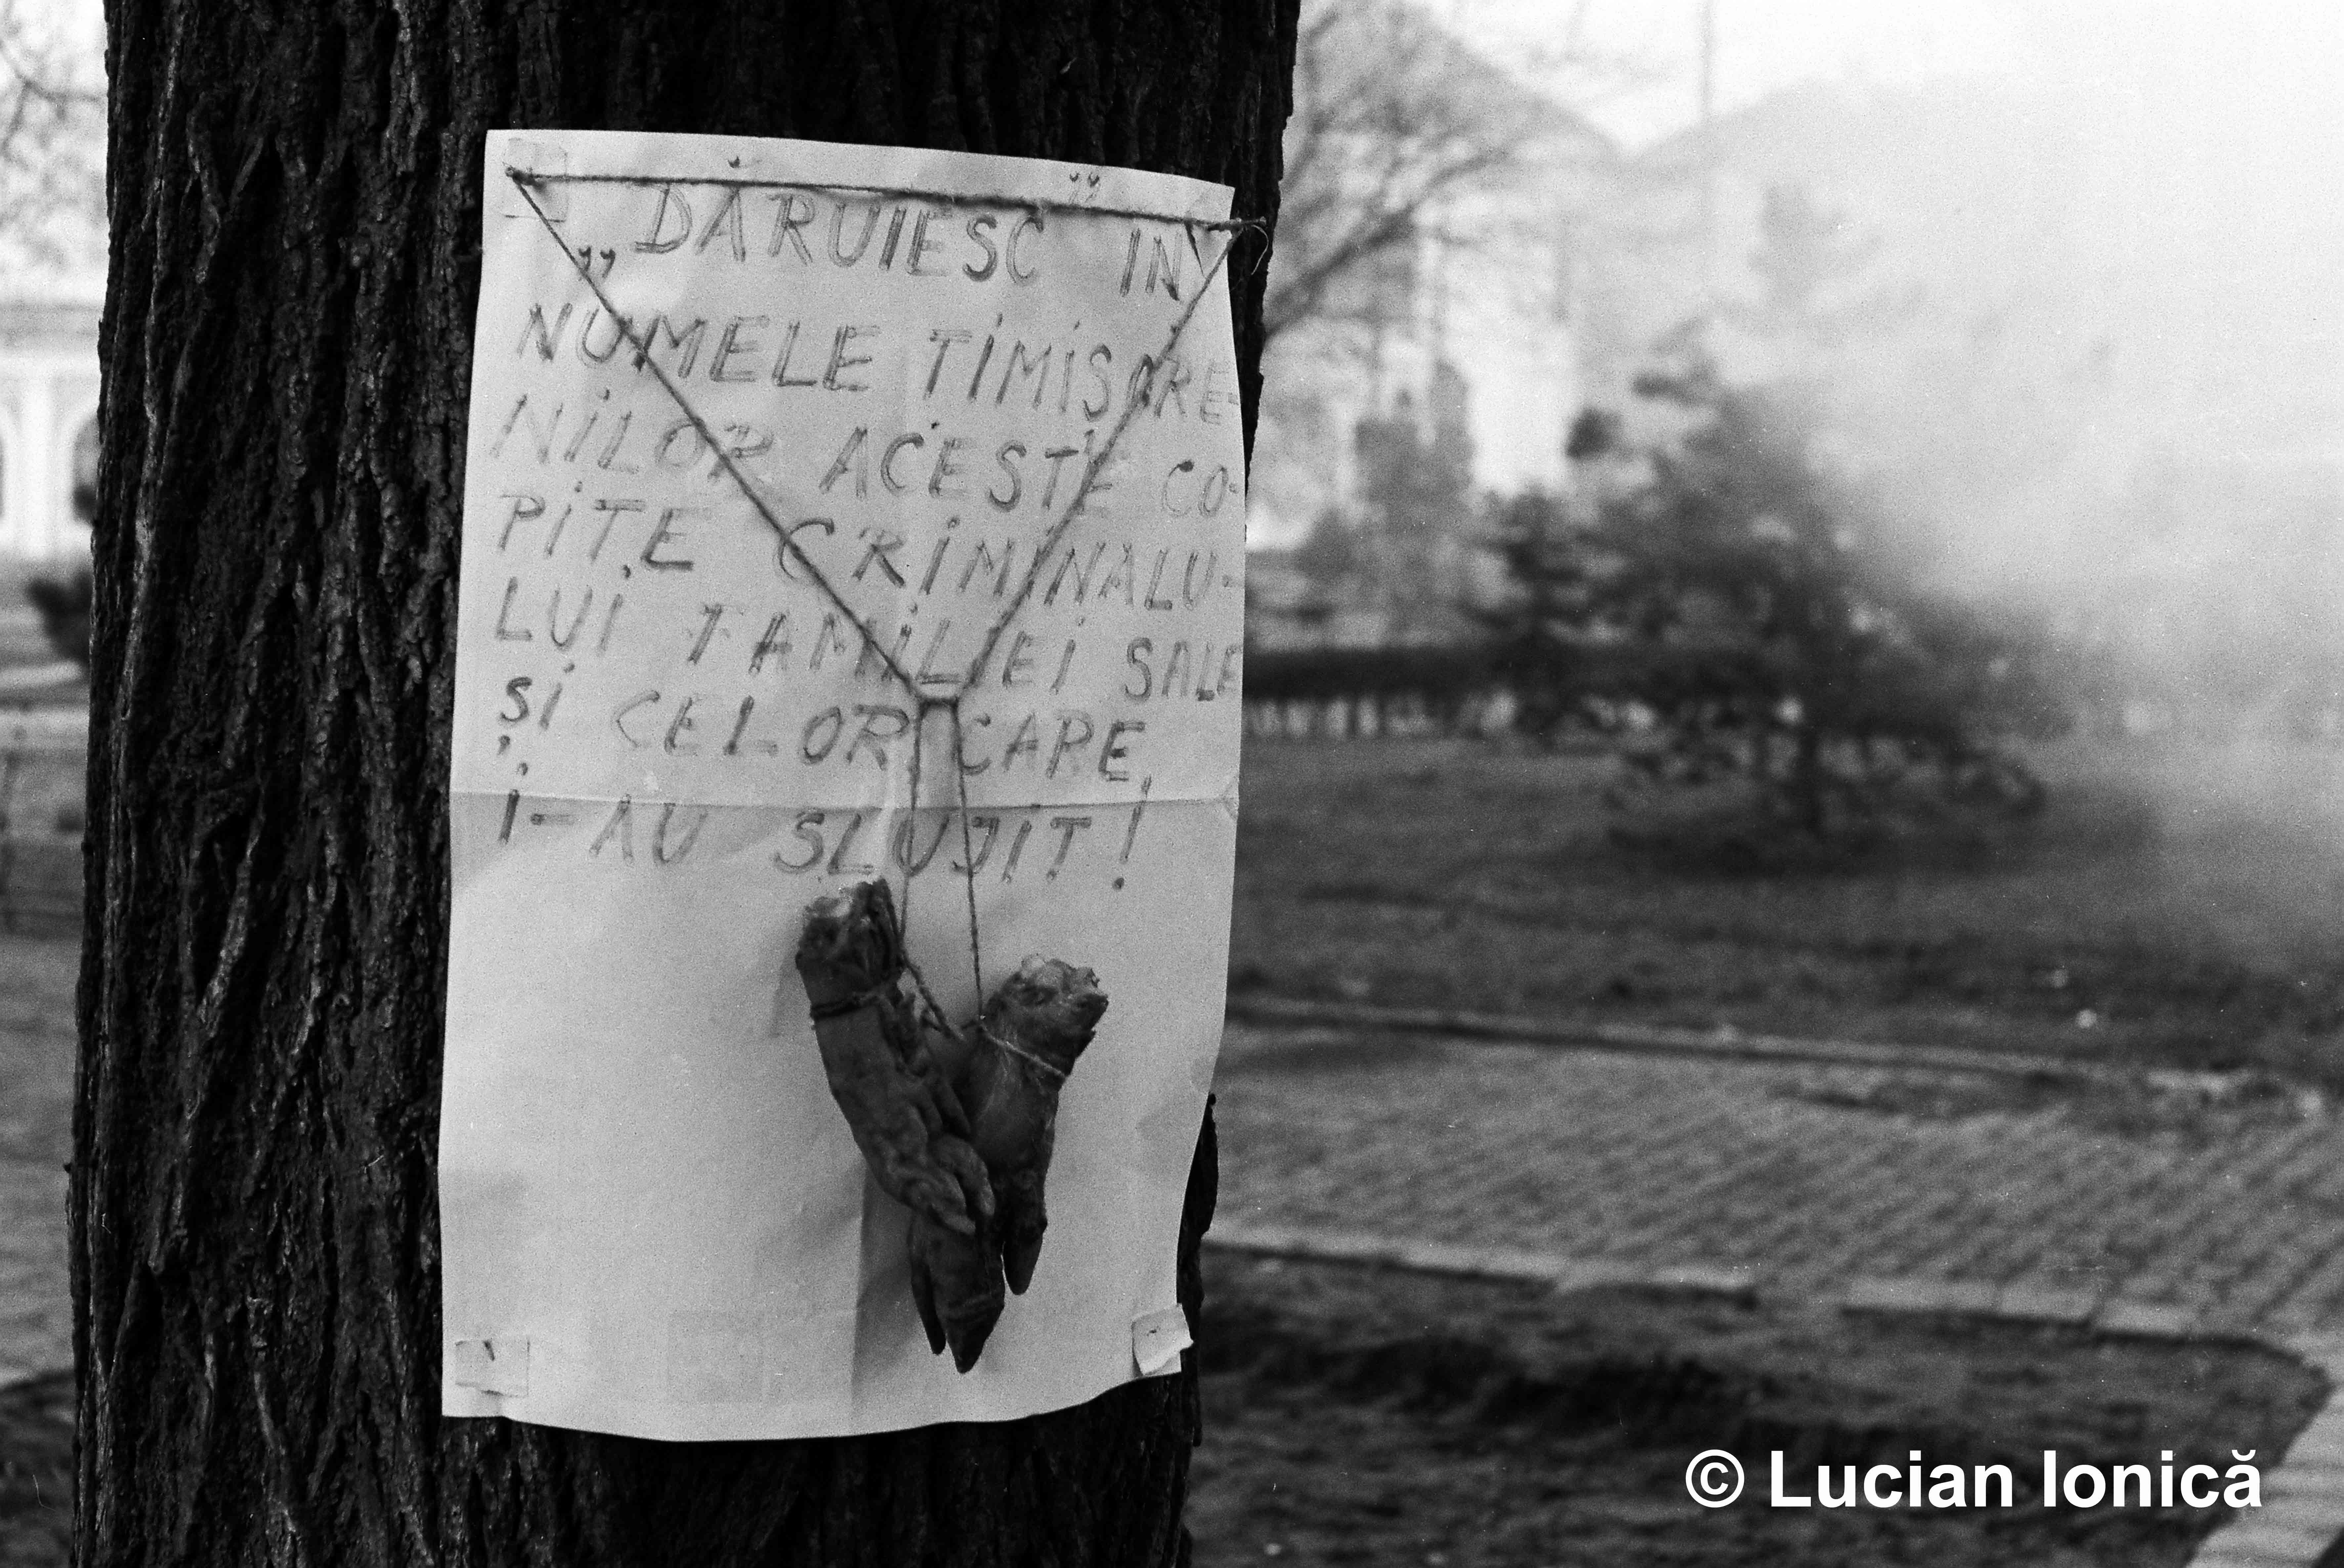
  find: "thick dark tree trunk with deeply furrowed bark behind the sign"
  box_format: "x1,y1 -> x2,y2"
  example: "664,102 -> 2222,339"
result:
73,0 -> 1294,1568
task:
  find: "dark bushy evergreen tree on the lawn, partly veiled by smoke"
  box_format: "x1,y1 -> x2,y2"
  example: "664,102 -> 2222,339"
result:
1496,194 -> 2060,834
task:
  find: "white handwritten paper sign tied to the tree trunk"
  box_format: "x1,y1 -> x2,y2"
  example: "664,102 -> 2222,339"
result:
441,131 -> 1245,1439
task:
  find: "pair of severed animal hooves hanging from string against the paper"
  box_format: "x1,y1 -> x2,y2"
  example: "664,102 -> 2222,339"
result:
797,881 -> 1106,1371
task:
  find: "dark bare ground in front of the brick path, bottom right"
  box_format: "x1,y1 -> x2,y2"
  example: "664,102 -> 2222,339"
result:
1188,1254 -> 2325,1568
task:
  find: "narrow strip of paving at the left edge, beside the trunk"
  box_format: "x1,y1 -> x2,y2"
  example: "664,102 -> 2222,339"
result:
0,938 -> 75,1383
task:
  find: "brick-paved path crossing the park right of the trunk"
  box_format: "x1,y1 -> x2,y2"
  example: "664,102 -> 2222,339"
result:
1216,1027 -> 2344,1331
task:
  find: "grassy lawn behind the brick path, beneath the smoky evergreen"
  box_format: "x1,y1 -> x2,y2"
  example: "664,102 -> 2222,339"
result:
1231,738 -> 2344,1087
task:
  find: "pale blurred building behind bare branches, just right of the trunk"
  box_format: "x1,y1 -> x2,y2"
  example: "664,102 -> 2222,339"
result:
1247,0 -> 1615,645
